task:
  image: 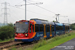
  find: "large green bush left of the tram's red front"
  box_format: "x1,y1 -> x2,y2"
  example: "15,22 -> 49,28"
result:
0,25 -> 14,40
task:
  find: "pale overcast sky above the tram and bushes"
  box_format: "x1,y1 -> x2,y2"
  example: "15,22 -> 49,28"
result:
0,0 -> 75,23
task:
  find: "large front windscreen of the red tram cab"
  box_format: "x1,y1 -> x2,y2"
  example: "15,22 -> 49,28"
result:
15,22 -> 29,33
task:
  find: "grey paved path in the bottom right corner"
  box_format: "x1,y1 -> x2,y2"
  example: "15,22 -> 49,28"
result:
51,38 -> 75,50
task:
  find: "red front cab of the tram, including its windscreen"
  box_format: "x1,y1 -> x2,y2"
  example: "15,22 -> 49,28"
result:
14,21 -> 34,38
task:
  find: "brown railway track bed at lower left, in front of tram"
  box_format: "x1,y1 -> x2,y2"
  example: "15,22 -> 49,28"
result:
0,41 -> 35,50
